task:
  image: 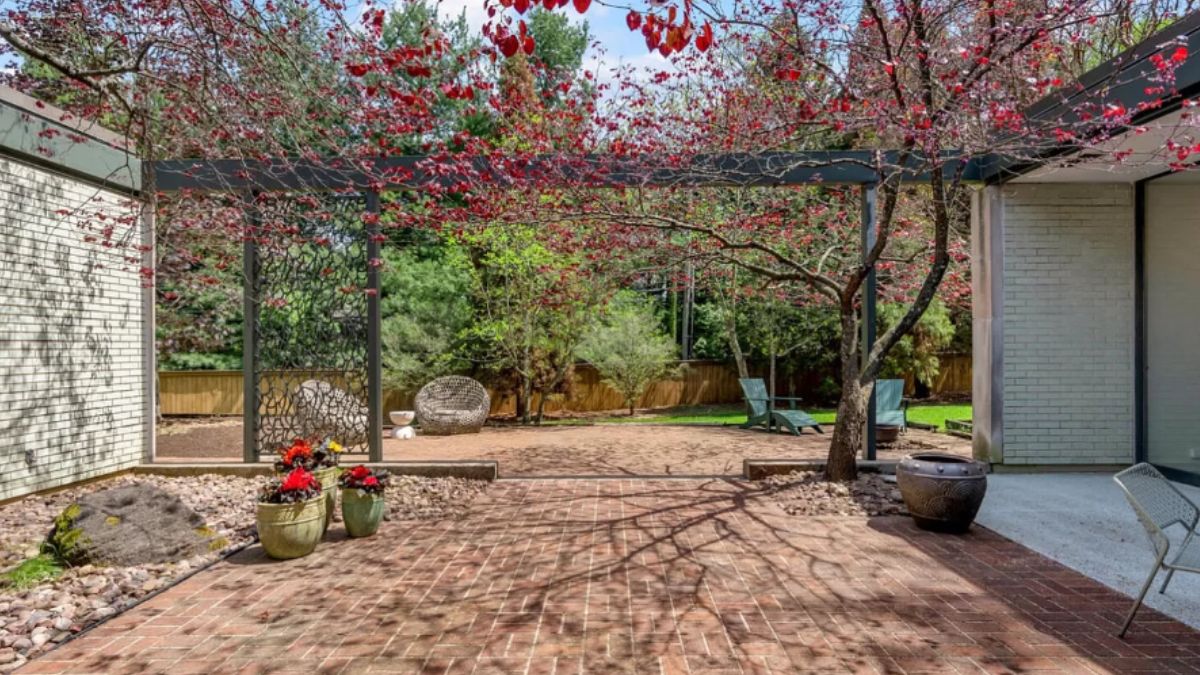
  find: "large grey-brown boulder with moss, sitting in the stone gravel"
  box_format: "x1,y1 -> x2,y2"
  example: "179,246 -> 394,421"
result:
42,483 -> 223,567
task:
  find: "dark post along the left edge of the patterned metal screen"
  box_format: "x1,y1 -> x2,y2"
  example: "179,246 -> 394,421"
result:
241,192 -> 262,464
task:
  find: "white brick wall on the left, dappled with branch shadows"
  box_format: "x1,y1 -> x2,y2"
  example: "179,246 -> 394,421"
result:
0,159 -> 146,500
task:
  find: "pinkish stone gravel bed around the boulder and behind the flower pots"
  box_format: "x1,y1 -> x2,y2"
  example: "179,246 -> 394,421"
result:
0,474 -> 487,673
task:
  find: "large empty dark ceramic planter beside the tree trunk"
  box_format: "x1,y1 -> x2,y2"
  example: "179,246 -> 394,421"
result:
896,453 -> 988,533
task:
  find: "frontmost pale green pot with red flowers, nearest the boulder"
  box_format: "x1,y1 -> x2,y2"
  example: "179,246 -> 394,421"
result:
258,467 -> 325,560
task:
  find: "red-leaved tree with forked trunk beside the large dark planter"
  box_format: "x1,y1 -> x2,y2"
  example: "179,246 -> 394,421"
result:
477,0 -> 1196,479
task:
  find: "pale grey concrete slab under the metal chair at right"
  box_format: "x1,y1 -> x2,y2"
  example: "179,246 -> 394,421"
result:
976,473 -> 1200,628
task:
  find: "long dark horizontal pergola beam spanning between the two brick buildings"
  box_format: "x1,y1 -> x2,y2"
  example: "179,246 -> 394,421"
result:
154,150 -> 991,192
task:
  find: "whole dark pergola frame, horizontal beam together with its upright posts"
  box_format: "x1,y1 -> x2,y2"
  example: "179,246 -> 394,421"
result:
154,150 -> 993,462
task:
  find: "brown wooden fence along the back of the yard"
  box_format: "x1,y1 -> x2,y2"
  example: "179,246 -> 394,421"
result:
158,354 -> 971,416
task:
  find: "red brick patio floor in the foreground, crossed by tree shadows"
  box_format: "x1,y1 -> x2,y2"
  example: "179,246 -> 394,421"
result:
22,479 -> 1200,675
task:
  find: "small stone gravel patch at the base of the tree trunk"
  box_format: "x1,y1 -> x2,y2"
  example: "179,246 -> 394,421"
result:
760,471 -> 908,516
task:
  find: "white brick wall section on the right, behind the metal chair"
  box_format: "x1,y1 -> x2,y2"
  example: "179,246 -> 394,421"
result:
1003,184 -> 1134,464
